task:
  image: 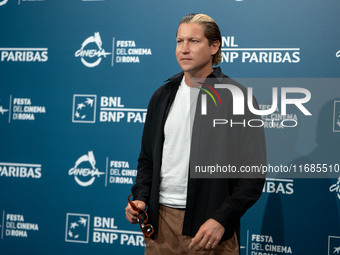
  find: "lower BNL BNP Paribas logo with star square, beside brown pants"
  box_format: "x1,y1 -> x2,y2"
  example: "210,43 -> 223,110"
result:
65,213 -> 145,247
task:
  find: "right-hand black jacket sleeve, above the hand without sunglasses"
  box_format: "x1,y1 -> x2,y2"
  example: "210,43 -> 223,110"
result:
212,95 -> 266,227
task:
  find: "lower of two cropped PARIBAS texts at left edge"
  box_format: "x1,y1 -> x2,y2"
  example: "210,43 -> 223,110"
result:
0,162 -> 42,179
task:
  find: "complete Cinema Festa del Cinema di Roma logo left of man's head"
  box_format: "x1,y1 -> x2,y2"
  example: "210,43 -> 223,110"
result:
75,32 -> 152,68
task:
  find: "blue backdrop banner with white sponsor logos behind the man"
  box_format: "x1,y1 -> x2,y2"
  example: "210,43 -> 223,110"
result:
0,0 -> 340,255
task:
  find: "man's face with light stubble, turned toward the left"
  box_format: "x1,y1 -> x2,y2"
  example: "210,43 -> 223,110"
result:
176,23 -> 220,74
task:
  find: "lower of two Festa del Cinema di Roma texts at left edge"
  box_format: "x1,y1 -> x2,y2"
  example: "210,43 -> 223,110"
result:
1,211 -> 39,239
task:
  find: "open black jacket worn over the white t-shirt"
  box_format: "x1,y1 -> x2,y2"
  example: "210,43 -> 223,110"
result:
132,68 -> 266,244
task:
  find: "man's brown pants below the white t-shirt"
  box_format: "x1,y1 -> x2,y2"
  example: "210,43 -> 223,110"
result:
145,205 -> 239,255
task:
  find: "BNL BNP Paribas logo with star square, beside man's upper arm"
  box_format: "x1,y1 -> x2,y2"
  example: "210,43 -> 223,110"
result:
72,94 -> 147,123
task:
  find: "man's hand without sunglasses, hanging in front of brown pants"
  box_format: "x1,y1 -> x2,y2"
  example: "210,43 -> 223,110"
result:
189,219 -> 225,251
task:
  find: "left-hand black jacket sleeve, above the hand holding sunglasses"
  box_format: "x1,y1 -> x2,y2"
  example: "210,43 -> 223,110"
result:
131,93 -> 155,204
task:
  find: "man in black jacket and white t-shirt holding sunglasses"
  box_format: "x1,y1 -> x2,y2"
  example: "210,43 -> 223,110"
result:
125,14 -> 266,255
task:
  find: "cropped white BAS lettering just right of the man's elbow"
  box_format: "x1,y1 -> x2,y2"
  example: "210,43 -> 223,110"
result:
263,178 -> 294,195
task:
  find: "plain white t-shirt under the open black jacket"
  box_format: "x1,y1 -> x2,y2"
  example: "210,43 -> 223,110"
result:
159,76 -> 199,208
